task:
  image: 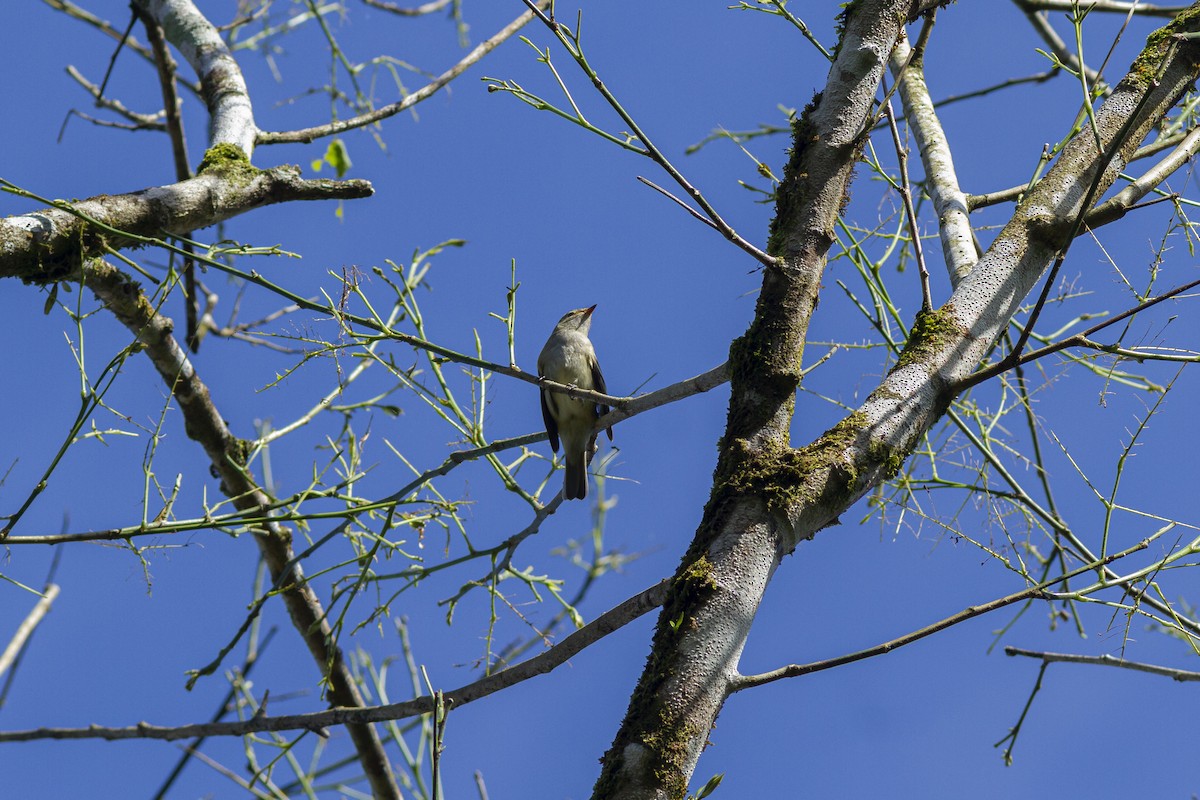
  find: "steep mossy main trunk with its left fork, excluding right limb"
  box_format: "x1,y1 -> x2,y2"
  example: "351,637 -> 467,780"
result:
593,0 -> 912,799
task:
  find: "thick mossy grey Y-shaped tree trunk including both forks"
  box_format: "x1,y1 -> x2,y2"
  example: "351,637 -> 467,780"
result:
593,0 -> 1200,799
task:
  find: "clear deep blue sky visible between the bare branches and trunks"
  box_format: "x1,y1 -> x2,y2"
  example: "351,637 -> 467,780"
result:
0,1 -> 1198,799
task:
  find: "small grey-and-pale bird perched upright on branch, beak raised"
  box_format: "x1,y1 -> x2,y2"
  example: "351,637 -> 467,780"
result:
538,306 -> 612,500
